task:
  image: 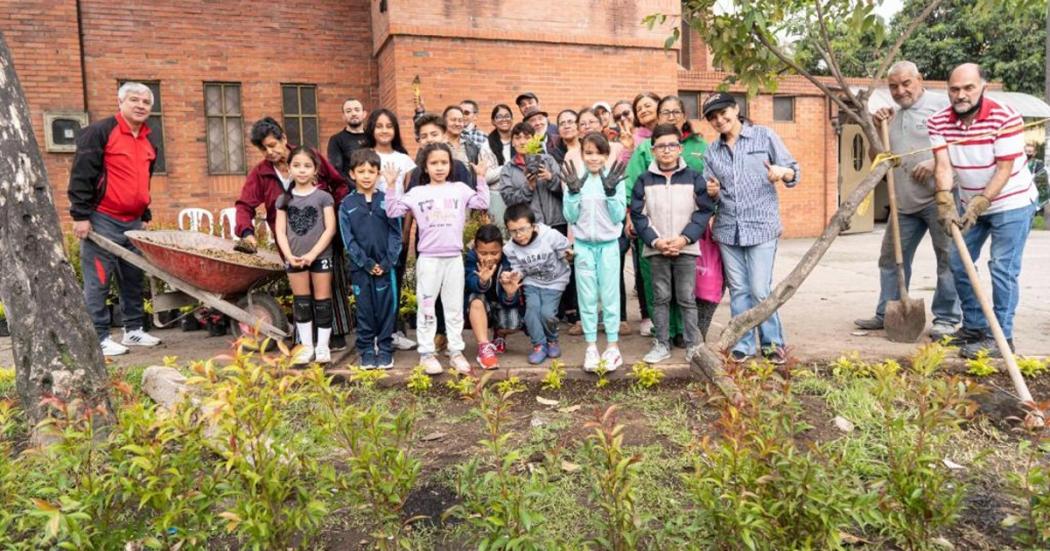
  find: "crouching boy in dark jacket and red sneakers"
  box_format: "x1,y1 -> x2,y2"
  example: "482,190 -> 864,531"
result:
464,224 -> 525,369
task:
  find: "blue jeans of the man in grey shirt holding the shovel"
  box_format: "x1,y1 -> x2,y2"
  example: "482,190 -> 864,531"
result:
875,205 -> 963,325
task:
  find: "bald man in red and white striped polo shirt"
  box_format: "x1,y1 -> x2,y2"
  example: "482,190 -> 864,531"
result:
927,63 -> 1037,358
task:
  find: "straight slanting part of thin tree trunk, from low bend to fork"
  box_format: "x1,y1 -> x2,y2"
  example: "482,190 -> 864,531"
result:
716,163 -> 894,349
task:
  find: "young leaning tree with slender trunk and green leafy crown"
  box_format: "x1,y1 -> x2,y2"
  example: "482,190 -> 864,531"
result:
645,0 -> 1033,398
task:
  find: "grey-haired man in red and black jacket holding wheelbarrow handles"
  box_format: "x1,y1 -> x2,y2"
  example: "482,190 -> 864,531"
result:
68,82 -> 161,356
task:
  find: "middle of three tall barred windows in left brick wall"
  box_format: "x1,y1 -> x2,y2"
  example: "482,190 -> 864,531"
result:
204,82 -> 246,174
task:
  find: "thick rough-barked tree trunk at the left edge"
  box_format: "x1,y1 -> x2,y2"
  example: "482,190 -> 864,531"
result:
0,33 -> 111,426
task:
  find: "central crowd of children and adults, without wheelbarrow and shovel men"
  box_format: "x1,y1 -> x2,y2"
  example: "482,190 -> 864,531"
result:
229,92 -> 799,374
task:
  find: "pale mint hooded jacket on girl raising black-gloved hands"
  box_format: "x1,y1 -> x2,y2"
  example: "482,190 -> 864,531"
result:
564,169 -> 627,242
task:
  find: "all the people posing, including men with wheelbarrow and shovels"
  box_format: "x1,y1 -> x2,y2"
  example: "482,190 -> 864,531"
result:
69,57 -> 1034,374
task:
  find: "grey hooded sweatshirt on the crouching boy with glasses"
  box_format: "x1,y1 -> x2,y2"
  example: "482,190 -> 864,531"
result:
503,224 -> 569,291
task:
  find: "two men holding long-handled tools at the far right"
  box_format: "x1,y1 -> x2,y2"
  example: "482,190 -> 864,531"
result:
855,61 -> 1043,358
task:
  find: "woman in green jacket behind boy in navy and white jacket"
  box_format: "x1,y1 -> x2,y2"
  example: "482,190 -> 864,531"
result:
627,96 -> 708,344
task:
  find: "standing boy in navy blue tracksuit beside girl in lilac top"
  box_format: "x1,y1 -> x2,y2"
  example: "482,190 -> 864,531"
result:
339,149 -> 401,369
